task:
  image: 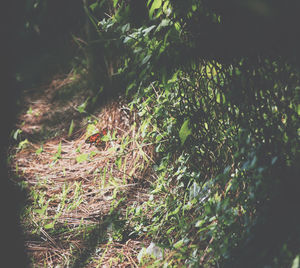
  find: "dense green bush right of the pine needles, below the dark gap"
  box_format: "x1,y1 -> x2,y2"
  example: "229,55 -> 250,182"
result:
131,56 -> 299,267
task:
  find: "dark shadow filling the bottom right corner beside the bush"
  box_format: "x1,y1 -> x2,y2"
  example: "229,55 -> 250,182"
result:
221,162 -> 300,268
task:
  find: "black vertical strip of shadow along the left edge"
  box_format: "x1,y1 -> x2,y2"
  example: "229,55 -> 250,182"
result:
0,1 -> 29,267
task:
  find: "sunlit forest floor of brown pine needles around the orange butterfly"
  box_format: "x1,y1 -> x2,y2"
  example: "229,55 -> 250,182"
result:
10,71 -> 154,267
